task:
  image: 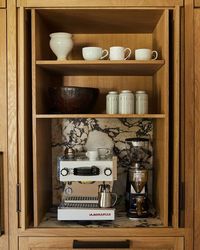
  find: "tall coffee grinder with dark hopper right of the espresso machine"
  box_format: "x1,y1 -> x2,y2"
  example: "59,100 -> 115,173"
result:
125,138 -> 150,218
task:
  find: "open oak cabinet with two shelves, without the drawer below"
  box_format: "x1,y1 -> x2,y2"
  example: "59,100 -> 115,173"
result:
18,1 -> 179,233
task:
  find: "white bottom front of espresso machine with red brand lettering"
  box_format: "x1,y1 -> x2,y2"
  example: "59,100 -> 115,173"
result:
57,207 -> 115,221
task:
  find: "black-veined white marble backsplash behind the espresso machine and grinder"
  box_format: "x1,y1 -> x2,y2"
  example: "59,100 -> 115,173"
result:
52,118 -> 153,205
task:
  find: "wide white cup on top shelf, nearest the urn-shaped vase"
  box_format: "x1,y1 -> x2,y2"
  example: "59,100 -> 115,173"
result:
82,47 -> 108,60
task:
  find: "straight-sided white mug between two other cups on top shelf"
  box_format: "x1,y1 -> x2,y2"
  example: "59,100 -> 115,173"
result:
109,46 -> 131,60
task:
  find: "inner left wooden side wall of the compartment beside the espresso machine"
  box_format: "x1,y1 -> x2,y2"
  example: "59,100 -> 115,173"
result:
33,120 -> 52,226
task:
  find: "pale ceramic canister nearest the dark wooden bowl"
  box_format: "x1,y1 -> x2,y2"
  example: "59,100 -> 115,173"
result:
106,91 -> 119,114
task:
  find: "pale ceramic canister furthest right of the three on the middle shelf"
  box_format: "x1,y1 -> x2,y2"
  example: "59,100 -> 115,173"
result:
135,90 -> 148,114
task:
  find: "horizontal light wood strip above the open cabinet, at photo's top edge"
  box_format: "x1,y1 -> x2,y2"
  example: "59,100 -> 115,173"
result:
17,0 -> 183,7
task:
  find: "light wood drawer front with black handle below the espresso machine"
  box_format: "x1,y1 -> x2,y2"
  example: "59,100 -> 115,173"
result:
19,237 -> 184,250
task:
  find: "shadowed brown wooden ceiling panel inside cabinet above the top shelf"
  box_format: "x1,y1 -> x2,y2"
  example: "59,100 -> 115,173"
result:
37,8 -> 163,34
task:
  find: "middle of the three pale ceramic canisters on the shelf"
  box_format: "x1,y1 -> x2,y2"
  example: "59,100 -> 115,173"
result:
119,90 -> 134,114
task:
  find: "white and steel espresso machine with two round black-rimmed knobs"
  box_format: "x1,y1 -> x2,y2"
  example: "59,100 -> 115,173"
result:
57,152 -> 117,220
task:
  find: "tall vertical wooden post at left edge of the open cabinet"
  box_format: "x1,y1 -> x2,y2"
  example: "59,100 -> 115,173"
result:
18,7 -> 33,229
